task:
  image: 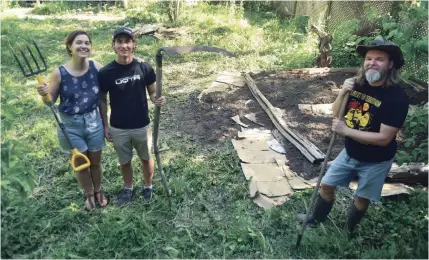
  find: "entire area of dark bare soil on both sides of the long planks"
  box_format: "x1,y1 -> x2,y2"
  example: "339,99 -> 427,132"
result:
173,70 -> 424,179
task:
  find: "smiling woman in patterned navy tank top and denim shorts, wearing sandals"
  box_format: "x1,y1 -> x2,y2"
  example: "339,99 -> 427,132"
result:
37,30 -> 107,210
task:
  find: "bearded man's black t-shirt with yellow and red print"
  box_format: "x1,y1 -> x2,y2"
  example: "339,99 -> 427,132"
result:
345,82 -> 409,162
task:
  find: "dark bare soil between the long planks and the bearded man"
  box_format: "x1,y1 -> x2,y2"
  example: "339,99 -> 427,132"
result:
252,70 -> 353,179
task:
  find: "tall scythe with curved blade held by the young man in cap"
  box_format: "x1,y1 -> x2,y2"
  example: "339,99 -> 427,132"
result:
153,46 -> 236,209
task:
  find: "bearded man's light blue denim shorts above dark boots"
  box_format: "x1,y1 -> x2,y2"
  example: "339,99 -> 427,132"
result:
322,149 -> 393,201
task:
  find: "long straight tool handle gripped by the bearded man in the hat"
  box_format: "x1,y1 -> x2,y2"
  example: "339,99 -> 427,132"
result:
295,93 -> 350,248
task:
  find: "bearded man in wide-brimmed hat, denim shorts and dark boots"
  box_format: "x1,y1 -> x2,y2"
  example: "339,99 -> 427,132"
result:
298,38 -> 409,232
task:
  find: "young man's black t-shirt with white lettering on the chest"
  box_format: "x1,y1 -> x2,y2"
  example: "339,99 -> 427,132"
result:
98,59 -> 156,129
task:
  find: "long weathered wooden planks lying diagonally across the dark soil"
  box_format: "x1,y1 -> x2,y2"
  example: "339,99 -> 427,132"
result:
245,73 -> 325,163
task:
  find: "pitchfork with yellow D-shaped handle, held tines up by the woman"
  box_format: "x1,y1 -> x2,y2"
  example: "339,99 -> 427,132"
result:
9,40 -> 91,171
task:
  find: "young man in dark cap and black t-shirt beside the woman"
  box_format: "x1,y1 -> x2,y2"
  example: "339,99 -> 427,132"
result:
98,27 -> 165,205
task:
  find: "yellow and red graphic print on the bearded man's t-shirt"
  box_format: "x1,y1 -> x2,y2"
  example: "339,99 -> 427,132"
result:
346,90 -> 381,131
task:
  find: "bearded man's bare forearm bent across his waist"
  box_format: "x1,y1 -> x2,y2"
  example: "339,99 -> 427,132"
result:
332,118 -> 399,146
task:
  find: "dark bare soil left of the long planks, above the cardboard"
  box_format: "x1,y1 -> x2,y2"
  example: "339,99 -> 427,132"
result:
166,83 -> 272,145
